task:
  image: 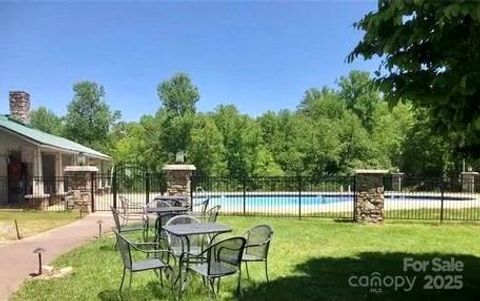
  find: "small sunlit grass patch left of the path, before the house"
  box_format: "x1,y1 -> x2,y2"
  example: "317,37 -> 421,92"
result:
0,211 -> 79,244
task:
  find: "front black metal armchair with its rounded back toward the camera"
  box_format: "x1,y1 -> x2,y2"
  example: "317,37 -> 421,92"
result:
180,237 -> 246,296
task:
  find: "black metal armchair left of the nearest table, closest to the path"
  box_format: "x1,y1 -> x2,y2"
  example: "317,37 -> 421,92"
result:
114,231 -> 176,293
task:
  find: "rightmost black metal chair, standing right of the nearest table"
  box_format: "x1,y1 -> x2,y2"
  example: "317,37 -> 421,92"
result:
242,225 -> 273,286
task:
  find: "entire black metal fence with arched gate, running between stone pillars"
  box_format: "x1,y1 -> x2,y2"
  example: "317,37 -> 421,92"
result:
0,166 -> 480,221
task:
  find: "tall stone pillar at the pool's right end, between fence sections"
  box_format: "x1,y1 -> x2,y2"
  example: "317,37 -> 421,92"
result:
355,169 -> 388,223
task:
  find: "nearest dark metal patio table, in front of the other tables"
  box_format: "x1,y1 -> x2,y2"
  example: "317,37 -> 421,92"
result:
163,223 -> 232,294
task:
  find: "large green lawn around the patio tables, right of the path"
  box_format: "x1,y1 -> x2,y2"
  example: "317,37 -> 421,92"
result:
12,217 -> 480,301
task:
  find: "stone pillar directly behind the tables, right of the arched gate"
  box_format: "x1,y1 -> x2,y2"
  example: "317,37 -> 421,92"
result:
163,164 -> 196,195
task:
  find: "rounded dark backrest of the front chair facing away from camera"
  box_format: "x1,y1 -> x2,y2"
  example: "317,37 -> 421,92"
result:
207,236 -> 247,275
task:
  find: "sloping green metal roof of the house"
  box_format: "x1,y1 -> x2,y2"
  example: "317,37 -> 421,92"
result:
0,115 -> 111,160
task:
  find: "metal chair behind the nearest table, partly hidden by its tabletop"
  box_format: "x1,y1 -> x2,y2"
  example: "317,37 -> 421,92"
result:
165,215 -> 205,257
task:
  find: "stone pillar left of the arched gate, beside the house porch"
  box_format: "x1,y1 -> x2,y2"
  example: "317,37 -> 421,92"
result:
64,166 -> 98,212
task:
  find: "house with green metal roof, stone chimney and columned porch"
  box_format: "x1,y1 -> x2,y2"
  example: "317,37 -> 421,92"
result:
0,91 -> 111,205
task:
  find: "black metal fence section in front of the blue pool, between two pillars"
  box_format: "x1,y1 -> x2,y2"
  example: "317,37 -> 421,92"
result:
191,176 -> 354,219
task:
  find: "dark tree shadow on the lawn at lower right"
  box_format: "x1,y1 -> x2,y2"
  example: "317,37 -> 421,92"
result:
241,252 -> 480,300
